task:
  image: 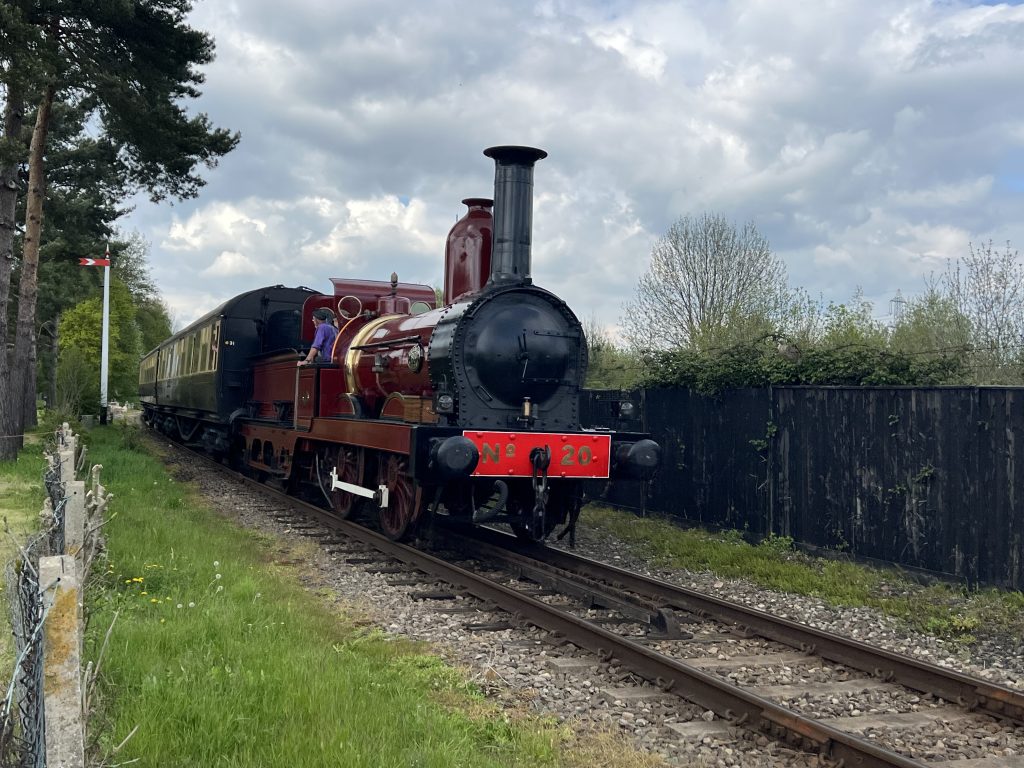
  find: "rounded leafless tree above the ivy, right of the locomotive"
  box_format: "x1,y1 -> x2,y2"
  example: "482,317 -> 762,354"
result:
623,213 -> 787,349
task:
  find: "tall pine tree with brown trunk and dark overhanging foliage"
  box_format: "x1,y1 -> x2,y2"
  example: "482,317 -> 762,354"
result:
0,0 -> 239,460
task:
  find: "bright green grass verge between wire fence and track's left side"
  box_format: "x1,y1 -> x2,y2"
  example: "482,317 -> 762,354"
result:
86,427 -> 654,768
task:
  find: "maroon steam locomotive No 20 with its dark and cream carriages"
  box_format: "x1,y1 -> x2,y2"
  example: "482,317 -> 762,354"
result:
139,146 -> 659,540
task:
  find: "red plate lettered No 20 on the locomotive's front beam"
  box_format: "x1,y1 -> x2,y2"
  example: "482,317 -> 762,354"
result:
463,429 -> 611,477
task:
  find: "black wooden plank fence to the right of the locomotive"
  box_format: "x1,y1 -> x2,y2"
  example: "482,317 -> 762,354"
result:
584,387 -> 1024,589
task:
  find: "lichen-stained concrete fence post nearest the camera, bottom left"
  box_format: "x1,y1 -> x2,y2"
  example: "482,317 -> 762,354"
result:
39,555 -> 85,768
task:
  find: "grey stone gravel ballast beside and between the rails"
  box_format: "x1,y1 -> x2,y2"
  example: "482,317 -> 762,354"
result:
157,446 -> 1024,767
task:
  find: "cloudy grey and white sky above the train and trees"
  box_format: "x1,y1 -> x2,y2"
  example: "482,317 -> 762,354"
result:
121,0 -> 1024,335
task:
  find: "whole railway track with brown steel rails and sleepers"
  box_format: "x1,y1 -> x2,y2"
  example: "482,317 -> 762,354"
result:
163,442 -> 1024,768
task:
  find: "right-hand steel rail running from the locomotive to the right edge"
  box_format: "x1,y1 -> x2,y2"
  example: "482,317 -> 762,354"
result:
471,528 -> 1024,725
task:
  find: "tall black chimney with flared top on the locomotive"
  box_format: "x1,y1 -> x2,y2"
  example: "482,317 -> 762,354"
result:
483,146 -> 548,287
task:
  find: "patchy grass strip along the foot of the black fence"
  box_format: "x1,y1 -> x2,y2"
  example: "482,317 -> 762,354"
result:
582,505 -> 1024,643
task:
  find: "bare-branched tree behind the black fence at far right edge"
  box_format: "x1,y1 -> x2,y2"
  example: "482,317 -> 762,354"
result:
942,241 -> 1024,384
